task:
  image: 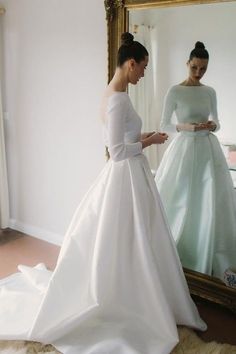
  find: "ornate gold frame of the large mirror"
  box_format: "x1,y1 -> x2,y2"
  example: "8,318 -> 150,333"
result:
104,0 -> 236,311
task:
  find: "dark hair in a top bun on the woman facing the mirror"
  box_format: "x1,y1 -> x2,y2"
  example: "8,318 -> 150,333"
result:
117,32 -> 148,67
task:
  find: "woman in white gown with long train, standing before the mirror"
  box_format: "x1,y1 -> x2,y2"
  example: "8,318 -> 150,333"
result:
0,33 -> 206,354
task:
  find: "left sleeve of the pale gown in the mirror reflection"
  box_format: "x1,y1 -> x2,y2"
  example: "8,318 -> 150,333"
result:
160,89 -> 176,133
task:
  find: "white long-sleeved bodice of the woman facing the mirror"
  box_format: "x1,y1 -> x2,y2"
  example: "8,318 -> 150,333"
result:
104,92 -> 142,161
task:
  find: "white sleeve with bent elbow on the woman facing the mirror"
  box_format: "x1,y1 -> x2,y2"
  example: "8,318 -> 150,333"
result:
107,95 -> 142,161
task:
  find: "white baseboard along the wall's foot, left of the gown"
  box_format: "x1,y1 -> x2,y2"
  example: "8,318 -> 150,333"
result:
9,219 -> 63,246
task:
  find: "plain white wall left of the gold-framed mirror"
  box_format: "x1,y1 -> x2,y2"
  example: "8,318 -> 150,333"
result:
1,0 -> 107,242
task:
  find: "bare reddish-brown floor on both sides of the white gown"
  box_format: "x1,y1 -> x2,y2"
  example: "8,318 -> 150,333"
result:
0,230 -> 236,345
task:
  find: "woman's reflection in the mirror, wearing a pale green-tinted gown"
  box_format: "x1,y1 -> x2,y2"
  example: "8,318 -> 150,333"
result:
155,42 -> 236,278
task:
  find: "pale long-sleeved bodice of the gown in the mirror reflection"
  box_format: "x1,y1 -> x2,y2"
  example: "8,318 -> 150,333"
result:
160,85 -> 220,132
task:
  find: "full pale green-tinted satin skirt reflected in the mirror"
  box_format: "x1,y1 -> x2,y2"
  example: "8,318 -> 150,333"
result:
155,131 -> 236,279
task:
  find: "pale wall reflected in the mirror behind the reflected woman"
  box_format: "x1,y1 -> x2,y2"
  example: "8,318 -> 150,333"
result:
131,2 -> 236,159
